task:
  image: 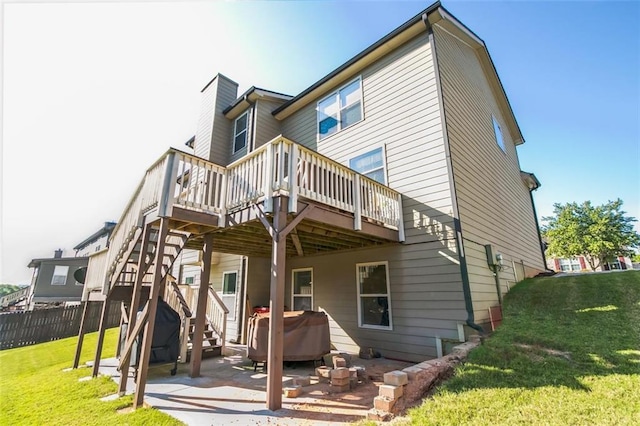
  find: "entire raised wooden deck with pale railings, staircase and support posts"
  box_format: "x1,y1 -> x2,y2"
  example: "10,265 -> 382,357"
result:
79,137 -> 404,410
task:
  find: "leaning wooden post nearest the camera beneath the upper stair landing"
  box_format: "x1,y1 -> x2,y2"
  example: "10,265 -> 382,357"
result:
133,218 -> 169,409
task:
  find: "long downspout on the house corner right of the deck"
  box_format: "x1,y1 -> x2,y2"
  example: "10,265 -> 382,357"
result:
422,13 -> 484,334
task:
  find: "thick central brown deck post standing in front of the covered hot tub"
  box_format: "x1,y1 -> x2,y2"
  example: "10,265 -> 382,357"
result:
267,197 -> 288,411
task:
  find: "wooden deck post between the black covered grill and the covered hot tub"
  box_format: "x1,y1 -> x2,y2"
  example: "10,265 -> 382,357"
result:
187,234 -> 213,378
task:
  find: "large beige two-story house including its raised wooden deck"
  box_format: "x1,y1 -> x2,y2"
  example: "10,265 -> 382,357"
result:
84,3 -> 545,409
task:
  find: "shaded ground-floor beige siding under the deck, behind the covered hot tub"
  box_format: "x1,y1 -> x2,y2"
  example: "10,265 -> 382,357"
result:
285,242 -> 466,361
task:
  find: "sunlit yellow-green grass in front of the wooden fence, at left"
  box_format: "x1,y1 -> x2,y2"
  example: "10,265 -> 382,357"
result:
0,328 -> 182,425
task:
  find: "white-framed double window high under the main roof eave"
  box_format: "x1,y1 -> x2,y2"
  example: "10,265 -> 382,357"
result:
316,77 -> 362,140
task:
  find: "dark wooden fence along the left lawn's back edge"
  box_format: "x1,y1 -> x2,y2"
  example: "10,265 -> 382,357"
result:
0,302 -> 120,350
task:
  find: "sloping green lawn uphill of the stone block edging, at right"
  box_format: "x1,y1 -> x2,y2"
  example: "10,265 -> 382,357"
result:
409,271 -> 640,425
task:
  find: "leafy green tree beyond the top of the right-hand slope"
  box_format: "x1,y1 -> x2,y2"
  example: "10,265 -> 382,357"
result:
542,199 -> 640,271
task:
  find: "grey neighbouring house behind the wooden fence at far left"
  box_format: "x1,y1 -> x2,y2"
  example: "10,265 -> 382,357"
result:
27,222 -> 115,310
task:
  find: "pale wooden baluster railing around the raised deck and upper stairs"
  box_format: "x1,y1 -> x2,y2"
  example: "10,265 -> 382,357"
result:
105,136 -> 403,290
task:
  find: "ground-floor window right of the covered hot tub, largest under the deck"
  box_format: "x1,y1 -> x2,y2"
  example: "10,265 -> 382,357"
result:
356,262 -> 392,330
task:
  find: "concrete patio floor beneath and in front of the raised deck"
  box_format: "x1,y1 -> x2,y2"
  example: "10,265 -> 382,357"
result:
95,346 -> 411,425
